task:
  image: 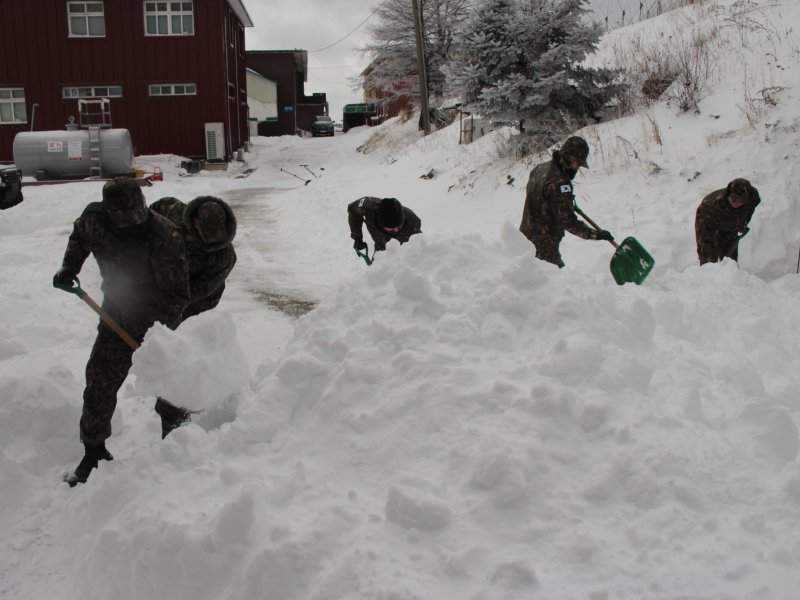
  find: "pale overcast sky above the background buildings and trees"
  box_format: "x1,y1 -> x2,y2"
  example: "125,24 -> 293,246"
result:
243,0 -> 672,121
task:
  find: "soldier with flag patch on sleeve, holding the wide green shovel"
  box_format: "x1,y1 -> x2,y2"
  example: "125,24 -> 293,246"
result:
519,137 -> 614,268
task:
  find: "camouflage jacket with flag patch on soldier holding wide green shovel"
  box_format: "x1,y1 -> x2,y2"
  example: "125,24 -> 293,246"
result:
519,152 -> 594,242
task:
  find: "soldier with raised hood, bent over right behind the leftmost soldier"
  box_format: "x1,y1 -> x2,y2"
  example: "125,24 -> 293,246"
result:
150,196 -> 236,320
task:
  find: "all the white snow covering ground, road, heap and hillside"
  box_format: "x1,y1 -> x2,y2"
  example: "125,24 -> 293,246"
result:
0,1 -> 800,600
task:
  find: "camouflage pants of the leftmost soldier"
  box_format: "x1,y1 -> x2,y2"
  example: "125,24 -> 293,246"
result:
80,311 -> 153,444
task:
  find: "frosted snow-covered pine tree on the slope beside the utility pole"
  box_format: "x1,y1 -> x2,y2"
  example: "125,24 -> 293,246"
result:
445,0 -> 623,150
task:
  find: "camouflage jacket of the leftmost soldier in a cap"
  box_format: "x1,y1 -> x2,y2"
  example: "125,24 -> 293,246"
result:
62,202 -> 189,327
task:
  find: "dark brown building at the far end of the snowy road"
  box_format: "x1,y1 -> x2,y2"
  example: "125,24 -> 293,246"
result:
246,50 -> 328,135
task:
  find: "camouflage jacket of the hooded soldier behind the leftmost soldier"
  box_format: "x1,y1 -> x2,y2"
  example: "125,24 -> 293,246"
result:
150,198 -> 236,317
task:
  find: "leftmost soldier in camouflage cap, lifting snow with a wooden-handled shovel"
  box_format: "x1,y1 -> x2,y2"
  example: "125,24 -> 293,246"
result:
53,177 -> 189,486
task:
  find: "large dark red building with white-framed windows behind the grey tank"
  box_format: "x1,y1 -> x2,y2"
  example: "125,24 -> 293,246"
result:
0,0 -> 253,162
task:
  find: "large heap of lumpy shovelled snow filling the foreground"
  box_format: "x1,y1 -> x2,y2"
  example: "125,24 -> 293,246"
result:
62,231 -> 800,600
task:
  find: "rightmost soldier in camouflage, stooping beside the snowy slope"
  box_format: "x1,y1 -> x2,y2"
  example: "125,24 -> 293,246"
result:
694,179 -> 761,265
